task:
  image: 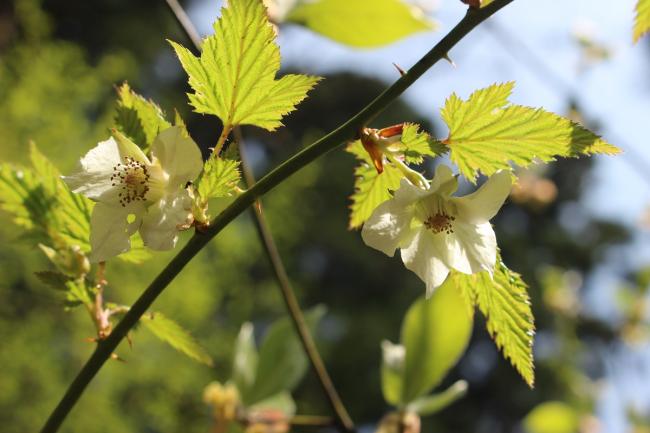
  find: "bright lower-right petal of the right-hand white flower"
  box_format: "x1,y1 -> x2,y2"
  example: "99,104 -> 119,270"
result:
445,221 -> 497,274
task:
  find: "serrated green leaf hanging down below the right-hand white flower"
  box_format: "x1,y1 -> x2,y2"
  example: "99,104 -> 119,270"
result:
450,258 -> 535,387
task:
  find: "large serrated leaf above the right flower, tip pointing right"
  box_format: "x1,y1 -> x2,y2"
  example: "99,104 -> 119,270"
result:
441,83 -> 620,181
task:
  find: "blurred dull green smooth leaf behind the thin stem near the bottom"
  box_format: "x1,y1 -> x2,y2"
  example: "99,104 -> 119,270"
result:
244,306 -> 325,405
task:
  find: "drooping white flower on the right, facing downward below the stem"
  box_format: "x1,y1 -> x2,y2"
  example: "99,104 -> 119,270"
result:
361,165 -> 511,295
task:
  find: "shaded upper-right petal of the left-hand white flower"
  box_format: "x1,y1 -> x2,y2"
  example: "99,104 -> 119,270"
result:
151,126 -> 203,189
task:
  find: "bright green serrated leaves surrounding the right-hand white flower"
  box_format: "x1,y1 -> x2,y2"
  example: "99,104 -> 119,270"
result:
348,83 -> 620,384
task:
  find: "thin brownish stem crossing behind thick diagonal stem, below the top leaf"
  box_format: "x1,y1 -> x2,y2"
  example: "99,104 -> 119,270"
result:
233,127 -> 355,432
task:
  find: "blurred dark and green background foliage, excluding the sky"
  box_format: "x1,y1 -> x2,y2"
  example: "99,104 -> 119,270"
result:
0,0 -> 647,433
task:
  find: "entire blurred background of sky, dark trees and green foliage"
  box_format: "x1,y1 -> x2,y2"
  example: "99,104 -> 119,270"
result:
0,0 -> 650,433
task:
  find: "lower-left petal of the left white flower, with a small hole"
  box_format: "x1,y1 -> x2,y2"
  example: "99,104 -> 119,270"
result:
90,203 -> 144,263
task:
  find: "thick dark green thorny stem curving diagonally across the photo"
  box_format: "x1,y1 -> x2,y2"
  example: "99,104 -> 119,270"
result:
41,0 -> 514,433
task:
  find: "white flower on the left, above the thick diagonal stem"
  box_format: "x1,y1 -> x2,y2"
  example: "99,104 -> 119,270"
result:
63,126 -> 203,262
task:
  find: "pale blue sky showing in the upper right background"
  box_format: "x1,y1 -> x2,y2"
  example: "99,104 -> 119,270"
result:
190,0 -> 650,433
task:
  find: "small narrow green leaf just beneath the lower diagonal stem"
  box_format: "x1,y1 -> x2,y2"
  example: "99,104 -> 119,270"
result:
140,313 -> 213,367
